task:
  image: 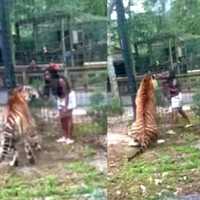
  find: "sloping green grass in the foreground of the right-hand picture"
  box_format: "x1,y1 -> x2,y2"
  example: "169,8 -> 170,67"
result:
109,126 -> 200,200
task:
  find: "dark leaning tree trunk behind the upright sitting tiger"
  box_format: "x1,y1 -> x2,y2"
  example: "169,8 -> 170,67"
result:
116,0 -> 136,120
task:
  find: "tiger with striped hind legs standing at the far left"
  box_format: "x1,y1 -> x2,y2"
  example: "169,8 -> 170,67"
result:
0,86 -> 41,166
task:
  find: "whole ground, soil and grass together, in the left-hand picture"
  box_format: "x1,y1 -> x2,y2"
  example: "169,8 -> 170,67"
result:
0,112 -> 107,200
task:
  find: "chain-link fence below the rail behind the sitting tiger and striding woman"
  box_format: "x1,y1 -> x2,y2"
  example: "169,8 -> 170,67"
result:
118,73 -> 200,127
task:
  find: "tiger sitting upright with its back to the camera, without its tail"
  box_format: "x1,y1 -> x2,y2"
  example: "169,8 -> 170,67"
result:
128,75 -> 158,149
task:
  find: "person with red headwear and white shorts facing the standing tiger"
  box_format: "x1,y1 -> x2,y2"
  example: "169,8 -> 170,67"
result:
44,64 -> 76,144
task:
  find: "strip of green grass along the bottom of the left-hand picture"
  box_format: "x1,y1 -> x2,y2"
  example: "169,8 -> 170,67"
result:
0,161 -> 106,200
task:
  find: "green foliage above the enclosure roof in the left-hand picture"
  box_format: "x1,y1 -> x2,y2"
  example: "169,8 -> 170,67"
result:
13,0 -> 106,21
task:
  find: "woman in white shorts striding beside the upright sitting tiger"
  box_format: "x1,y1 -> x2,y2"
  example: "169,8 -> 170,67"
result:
167,71 -> 192,128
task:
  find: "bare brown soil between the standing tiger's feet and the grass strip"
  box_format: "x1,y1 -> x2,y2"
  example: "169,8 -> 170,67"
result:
2,114 -> 107,183
